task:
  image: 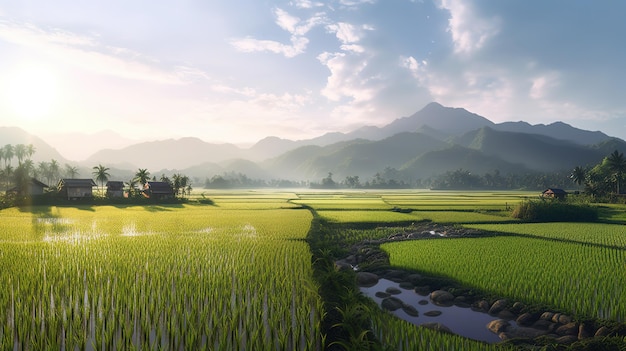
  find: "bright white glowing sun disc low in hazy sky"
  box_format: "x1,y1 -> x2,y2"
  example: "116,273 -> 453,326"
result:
8,65 -> 59,121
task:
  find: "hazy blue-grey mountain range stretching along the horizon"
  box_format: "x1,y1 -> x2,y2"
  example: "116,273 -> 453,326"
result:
0,102 -> 626,181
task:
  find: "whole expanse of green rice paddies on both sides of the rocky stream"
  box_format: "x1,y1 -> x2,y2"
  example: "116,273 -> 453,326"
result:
0,190 -> 626,350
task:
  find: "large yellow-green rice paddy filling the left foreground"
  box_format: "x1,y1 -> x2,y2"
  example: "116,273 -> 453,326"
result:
0,200 -> 323,350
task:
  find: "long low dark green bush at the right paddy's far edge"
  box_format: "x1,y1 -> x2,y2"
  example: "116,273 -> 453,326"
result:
512,199 -> 598,222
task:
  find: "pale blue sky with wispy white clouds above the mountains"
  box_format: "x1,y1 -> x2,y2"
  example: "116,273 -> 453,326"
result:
0,0 -> 626,157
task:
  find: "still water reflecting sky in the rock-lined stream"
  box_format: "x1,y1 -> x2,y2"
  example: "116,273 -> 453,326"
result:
361,279 -> 515,343
